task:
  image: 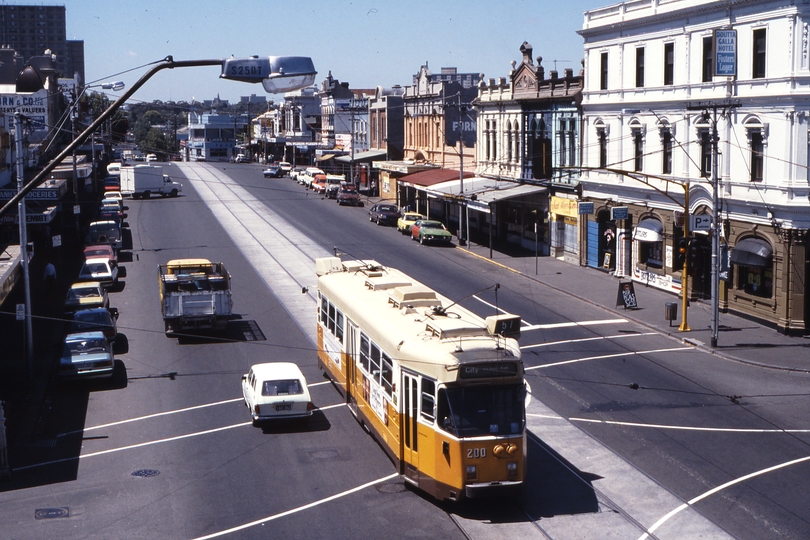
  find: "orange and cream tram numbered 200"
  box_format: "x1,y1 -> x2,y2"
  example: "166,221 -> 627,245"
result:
316,257 -> 526,500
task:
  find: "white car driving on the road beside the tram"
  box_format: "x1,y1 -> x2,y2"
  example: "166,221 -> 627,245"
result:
242,362 -> 313,425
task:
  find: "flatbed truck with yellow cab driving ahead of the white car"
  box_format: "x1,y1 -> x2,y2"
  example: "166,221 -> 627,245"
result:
158,259 -> 233,336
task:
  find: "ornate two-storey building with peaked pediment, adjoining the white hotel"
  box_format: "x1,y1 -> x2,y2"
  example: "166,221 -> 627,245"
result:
471,42 -> 583,263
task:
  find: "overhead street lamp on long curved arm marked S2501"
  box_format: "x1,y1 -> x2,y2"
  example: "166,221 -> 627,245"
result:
0,56 -> 318,221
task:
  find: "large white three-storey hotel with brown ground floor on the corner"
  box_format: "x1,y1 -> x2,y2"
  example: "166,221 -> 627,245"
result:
579,0 -> 810,333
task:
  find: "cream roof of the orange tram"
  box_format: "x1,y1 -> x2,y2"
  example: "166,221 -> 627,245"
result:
319,261 -> 520,379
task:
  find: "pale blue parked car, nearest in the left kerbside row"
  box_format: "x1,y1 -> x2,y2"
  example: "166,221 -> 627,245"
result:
59,332 -> 114,378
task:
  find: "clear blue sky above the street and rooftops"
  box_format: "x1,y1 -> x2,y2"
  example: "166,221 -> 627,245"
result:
60,0 -> 615,101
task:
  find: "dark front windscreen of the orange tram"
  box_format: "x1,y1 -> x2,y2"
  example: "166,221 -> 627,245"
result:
437,384 -> 526,437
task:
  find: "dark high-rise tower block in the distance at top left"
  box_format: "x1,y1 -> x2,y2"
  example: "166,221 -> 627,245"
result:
0,4 -> 84,85
